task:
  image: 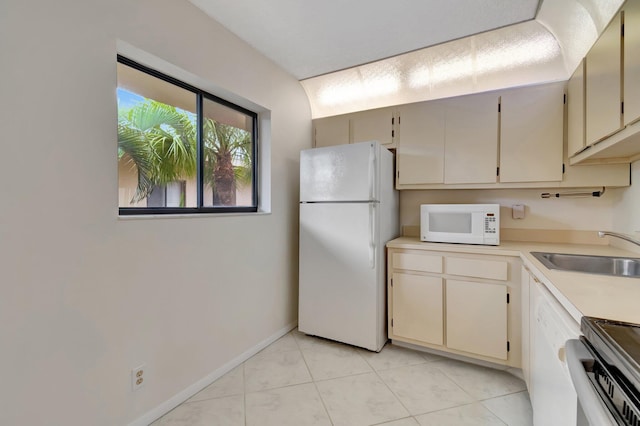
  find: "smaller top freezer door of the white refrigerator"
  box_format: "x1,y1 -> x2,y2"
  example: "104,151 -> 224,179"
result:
300,141 -> 380,202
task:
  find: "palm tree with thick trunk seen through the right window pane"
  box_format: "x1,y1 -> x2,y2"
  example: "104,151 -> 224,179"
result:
203,118 -> 253,206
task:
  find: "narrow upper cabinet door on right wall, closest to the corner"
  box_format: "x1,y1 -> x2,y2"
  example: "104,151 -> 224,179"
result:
567,59 -> 584,157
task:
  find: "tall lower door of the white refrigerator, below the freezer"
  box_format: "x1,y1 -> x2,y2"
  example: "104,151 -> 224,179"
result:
298,203 -> 386,351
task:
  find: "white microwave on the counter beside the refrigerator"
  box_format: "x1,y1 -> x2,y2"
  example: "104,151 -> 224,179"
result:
420,204 -> 500,246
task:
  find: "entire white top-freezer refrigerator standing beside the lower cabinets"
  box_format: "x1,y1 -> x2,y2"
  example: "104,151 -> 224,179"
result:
298,141 -> 399,351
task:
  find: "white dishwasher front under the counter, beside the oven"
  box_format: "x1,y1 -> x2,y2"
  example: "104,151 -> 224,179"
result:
529,280 -> 580,426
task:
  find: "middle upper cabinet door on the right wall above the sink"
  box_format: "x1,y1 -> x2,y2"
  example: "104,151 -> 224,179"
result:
585,14 -> 621,145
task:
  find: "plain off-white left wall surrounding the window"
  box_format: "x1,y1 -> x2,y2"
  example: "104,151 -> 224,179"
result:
0,0 -> 311,426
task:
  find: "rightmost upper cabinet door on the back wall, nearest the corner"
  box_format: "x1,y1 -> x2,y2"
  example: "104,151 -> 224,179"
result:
500,83 -> 564,182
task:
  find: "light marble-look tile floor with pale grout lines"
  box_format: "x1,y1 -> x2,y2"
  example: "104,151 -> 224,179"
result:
153,330 -> 533,426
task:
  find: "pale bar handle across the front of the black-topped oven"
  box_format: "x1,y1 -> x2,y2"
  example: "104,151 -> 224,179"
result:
565,339 -> 618,426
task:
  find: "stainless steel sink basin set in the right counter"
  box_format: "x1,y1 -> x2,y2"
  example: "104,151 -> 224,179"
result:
531,251 -> 640,277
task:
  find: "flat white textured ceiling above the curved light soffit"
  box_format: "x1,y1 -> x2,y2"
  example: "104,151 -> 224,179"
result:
190,0 -> 539,80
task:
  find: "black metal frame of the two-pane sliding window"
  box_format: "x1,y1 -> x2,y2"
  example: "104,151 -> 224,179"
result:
117,55 -> 259,216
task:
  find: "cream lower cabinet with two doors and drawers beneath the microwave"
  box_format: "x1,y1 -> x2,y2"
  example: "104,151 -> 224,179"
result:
388,249 -> 521,367
